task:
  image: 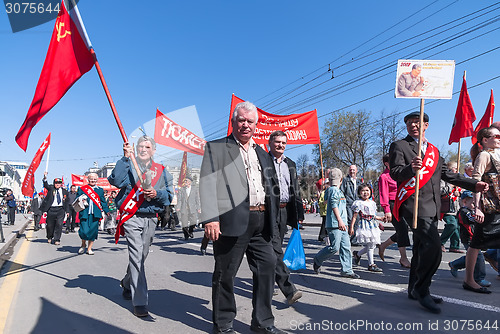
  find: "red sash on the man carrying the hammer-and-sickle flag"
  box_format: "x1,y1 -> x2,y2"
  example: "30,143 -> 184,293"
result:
115,161 -> 165,243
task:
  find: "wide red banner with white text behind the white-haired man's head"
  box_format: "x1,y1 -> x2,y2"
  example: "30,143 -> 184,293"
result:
227,94 -> 320,145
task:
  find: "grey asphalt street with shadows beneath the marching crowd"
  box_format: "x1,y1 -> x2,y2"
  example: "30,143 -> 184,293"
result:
0,215 -> 500,334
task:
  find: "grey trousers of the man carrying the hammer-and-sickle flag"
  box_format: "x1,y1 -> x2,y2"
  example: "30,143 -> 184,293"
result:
123,216 -> 158,306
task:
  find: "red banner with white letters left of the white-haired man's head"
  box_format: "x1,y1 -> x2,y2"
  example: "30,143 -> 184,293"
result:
154,109 -> 206,155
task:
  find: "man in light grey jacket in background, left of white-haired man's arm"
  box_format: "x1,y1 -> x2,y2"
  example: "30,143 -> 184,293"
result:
177,175 -> 200,240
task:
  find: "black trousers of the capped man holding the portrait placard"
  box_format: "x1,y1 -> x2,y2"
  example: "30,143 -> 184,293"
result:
401,217 -> 442,297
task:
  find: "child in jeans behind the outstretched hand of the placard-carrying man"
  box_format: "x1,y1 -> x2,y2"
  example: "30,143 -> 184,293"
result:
448,190 -> 491,287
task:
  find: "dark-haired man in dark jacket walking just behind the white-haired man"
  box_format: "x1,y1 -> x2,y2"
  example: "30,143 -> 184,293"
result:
269,131 -> 304,305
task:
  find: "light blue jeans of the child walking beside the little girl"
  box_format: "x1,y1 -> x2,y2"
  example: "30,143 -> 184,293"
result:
314,227 -> 353,274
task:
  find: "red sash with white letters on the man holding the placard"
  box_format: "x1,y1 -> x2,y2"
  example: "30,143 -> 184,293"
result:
394,142 -> 439,221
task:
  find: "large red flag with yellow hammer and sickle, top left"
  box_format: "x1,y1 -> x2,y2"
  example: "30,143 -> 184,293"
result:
16,0 -> 95,151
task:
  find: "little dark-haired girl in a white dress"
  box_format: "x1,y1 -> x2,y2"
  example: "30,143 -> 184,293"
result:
349,183 -> 384,273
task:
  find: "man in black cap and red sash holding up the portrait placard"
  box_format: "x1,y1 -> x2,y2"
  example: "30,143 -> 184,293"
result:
389,112 -> 488,313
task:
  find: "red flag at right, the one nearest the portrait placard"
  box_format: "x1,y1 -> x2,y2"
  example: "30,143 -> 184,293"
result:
448,75 -> 476,144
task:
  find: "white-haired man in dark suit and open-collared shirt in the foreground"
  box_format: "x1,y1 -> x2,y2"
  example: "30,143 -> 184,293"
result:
200,102 -> 284,333
